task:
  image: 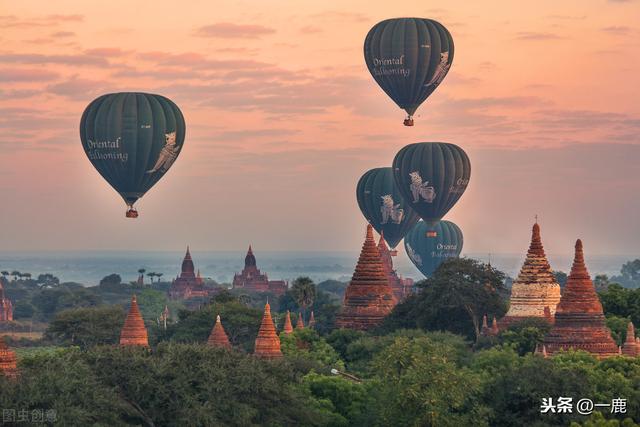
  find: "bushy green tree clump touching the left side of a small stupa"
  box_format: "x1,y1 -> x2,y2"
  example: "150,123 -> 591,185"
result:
45,306 -> 125,348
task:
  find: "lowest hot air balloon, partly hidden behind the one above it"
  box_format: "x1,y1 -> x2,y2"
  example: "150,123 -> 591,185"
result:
404,221 -> 463,277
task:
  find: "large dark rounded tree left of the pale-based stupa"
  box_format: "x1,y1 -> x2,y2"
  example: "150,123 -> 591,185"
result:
382,258 -> 506,340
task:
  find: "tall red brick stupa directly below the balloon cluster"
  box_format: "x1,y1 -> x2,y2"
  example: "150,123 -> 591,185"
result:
336,224 -> 395,330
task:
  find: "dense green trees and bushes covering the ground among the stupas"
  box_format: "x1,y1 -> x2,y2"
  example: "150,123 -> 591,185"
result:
0,259 -> 640,427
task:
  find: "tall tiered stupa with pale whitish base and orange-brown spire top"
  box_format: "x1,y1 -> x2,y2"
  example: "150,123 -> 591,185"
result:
499,222 -> 560,328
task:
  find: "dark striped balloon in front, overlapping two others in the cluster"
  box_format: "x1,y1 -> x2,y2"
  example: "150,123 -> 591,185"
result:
393,142 -> 471,223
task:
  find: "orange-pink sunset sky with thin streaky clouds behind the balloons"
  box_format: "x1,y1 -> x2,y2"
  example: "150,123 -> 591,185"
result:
0,0 -> 640,254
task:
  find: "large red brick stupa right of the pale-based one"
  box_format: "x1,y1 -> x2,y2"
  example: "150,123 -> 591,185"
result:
544,239 -> 618,359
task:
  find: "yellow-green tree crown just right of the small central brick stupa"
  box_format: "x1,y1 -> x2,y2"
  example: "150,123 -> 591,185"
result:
280,328 -> 344,369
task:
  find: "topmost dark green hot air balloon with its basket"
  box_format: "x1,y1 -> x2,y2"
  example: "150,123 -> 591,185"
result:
364,18 -> 453,126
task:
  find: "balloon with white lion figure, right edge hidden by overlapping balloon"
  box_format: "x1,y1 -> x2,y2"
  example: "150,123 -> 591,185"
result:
356,168 -> 419,248
